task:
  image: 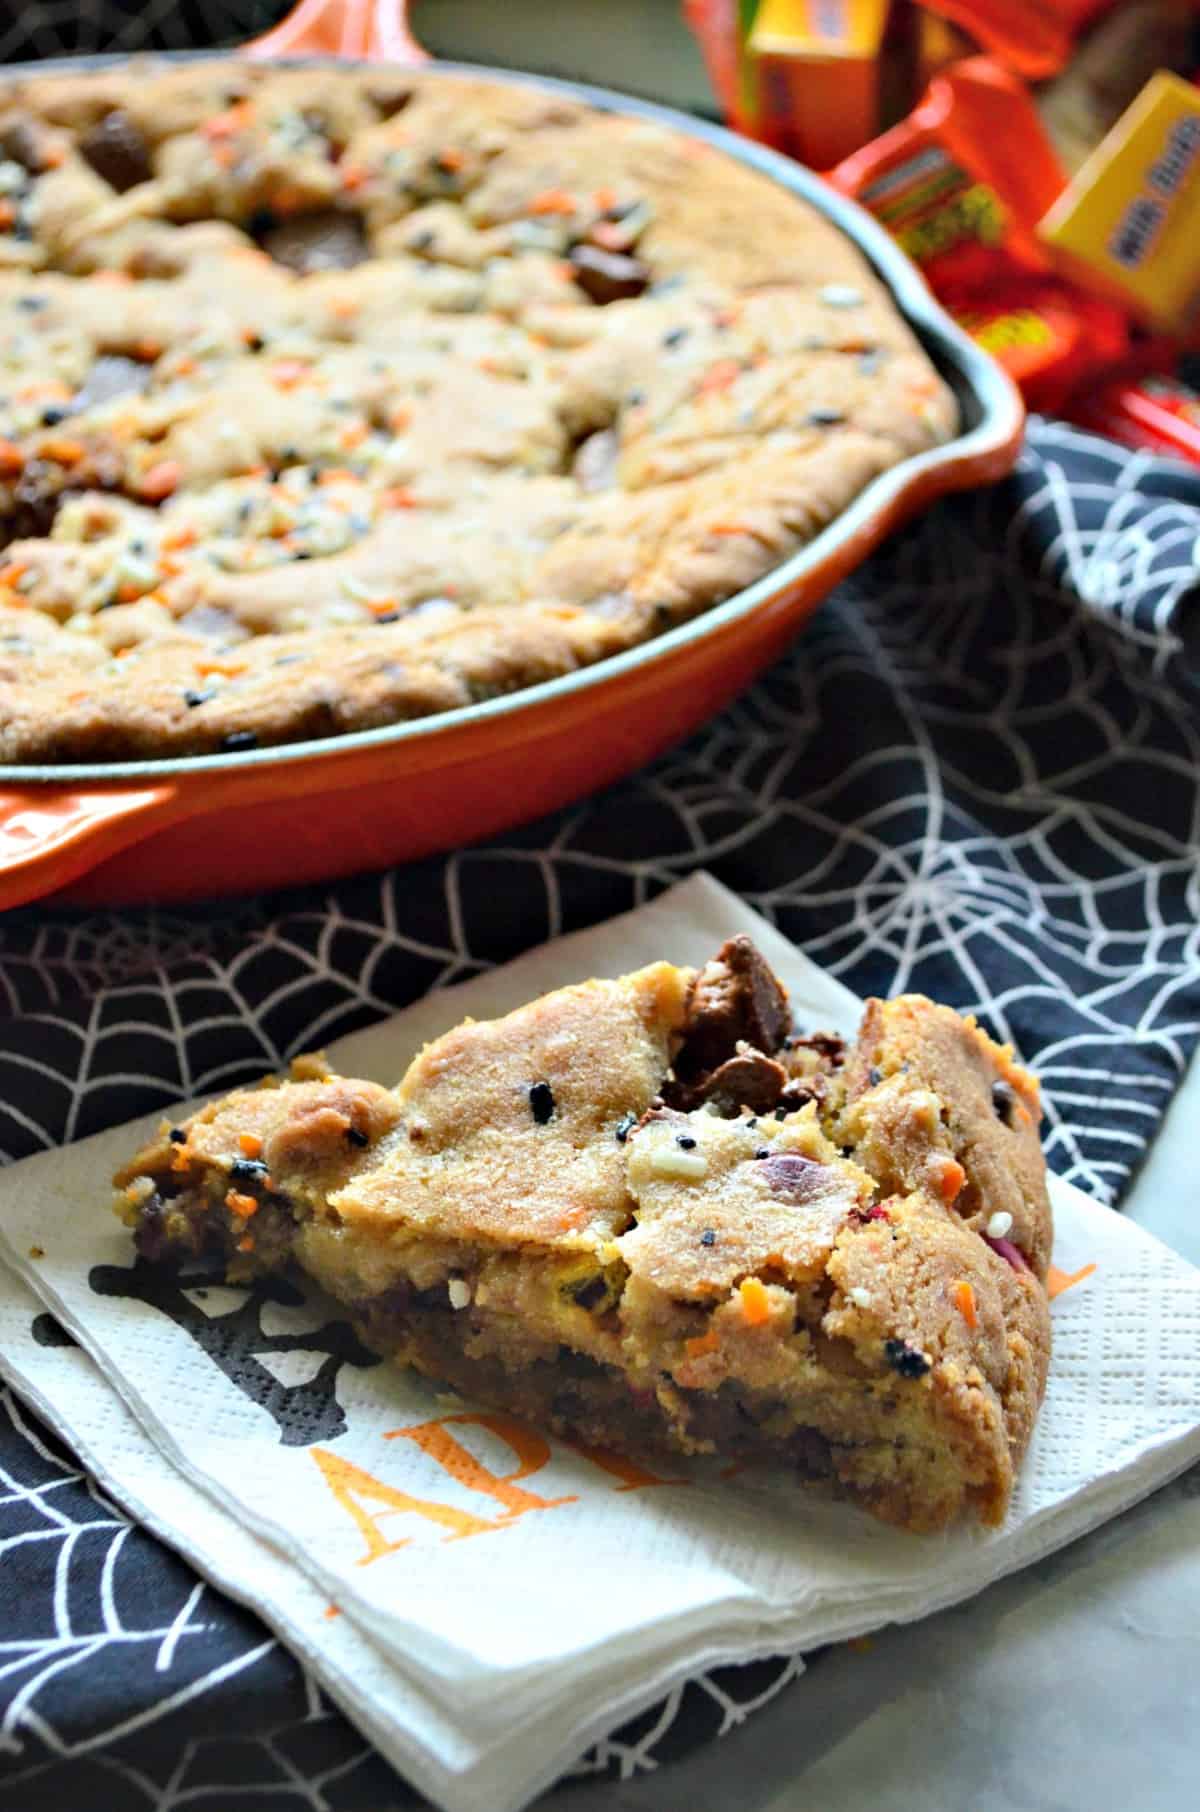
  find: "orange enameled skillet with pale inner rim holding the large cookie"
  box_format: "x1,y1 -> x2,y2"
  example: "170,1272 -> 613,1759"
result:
0,0 -> 1022,908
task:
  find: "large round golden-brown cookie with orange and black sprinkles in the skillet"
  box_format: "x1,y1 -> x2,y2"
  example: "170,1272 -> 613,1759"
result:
0,60 -> 957,763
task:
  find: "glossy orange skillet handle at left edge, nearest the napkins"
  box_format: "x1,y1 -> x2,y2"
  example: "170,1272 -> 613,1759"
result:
0,786 -> 176,911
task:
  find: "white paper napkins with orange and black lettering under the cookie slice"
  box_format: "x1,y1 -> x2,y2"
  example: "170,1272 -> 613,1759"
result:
0,877 -> 1200,1812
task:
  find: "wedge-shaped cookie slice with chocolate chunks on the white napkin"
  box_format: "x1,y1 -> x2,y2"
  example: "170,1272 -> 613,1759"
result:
116,939 -> 1050,1529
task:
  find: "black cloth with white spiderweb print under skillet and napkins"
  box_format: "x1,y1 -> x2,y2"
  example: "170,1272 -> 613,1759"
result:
0,411 -> 1200,1812
